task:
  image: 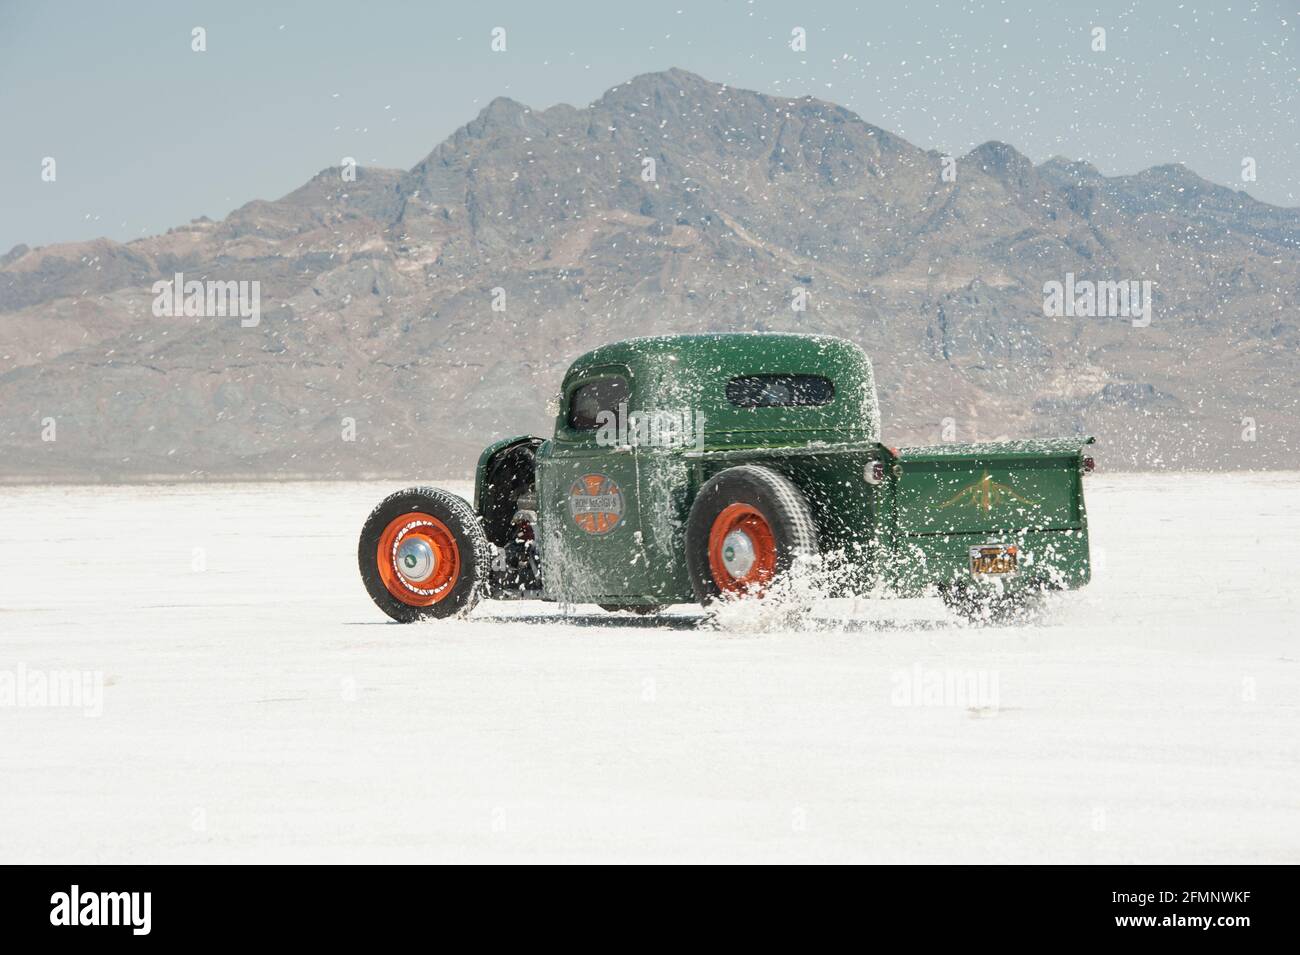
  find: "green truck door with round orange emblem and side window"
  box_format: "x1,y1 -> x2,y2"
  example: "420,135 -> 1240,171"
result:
537,365 -> 650,603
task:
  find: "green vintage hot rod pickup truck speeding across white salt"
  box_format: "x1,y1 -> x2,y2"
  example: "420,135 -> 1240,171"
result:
358,334 -> 1092,622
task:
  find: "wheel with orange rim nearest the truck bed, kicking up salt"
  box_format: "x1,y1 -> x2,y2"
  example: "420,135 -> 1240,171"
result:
686,464 -> 819,605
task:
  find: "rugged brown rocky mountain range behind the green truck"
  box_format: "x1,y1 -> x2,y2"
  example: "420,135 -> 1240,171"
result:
0,70 -> 1300,479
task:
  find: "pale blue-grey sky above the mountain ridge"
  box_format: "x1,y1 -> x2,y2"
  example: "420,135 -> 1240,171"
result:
0,0 -> 1300,252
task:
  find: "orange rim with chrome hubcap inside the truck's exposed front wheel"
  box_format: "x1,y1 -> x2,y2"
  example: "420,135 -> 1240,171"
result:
374,511 -> 460,607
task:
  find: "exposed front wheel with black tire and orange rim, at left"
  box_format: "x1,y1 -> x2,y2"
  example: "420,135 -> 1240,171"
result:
356,487 -> 491,624
